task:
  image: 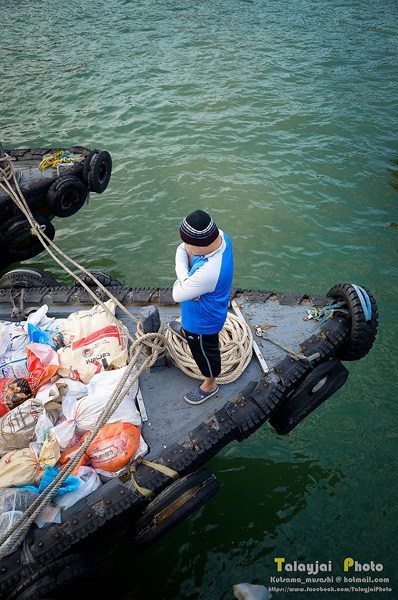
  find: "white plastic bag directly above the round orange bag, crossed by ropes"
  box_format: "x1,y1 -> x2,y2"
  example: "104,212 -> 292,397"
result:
51,367 -> 141,450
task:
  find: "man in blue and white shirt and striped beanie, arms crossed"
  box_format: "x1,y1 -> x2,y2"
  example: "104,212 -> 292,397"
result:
168,210 -> 233,404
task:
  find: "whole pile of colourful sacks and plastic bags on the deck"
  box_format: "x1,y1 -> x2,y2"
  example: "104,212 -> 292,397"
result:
0,300 -> 148,534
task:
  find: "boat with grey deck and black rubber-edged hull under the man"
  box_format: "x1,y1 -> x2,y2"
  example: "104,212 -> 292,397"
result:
0,281 -> 377,594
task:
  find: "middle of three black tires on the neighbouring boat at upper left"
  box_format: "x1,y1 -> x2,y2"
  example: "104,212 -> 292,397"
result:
46,174 -> 88,218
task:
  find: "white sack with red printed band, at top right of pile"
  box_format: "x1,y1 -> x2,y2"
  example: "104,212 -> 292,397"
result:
58,300 -> 128,383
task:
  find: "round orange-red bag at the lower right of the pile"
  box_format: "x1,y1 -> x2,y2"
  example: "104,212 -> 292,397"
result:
82,423 -> 140,472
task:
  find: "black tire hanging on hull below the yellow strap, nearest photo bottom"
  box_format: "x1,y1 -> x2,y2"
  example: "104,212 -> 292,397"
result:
129,469 -> 220,550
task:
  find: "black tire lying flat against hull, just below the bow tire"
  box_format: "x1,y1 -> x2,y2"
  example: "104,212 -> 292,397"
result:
269,358 -> 348,435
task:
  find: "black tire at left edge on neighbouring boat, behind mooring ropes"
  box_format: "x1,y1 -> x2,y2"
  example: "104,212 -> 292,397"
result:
0,213 -> 55,263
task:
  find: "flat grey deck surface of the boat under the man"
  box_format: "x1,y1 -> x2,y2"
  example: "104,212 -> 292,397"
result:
16,295 -> 330,460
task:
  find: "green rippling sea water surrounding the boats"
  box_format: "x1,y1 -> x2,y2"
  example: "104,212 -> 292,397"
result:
0,0 -> 398,600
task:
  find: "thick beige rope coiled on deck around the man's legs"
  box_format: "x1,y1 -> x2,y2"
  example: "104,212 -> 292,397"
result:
166,313 -> 253,383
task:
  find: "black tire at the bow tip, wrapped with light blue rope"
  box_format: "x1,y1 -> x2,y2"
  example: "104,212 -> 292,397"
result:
327,283 -> 379,361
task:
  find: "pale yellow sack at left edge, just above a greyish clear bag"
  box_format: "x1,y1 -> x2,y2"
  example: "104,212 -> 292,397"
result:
0,447 -> 42,487
